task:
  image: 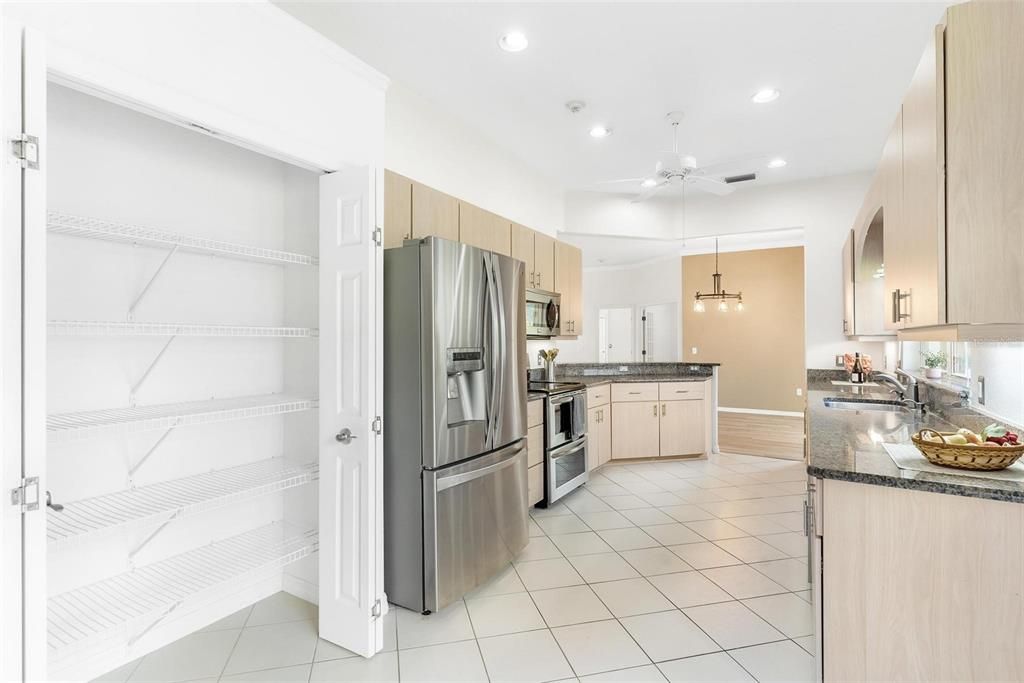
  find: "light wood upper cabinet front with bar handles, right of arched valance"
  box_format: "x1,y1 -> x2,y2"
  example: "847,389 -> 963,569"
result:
886,28 -> 946,328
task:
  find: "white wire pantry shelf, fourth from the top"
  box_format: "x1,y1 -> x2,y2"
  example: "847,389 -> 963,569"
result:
46,458 -> 317,547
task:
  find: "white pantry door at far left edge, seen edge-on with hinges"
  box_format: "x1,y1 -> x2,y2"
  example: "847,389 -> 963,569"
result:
0,19 -> 46,681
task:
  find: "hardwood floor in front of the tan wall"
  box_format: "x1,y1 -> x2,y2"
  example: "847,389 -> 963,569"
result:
718,413 -> 804,460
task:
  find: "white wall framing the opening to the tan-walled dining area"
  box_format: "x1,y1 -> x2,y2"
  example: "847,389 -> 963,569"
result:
565,173 -> 892,368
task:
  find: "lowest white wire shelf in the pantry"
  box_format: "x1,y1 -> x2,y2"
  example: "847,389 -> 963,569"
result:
47,523 -> 316,661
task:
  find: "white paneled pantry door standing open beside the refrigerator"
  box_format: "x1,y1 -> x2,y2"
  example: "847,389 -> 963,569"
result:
318,167 -> 387,657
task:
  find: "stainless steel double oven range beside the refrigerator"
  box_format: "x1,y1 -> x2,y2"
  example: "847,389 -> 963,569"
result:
529,382 -> 588,505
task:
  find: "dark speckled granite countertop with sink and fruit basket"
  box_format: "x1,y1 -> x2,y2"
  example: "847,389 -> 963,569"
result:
807,379 -> 1024,503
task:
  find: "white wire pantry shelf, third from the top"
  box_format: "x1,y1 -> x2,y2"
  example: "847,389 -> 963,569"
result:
46,394 -> 317,443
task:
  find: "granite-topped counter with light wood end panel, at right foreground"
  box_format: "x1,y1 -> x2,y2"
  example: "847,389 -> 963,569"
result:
806,381 -> 1024,681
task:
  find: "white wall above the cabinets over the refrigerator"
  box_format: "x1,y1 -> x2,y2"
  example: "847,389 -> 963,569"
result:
384,82 -> 565,236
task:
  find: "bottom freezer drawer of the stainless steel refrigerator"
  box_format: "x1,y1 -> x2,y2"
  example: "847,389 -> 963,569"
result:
423,439 -> 528,611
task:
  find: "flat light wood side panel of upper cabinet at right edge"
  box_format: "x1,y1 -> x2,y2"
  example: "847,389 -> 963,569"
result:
945,2 -> 1024,324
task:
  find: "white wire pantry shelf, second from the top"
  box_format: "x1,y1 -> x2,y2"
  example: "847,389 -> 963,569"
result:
46,321 -> 319,338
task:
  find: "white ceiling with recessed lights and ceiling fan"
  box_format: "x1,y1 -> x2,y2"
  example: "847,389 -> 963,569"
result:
279,1 -> 948,189
